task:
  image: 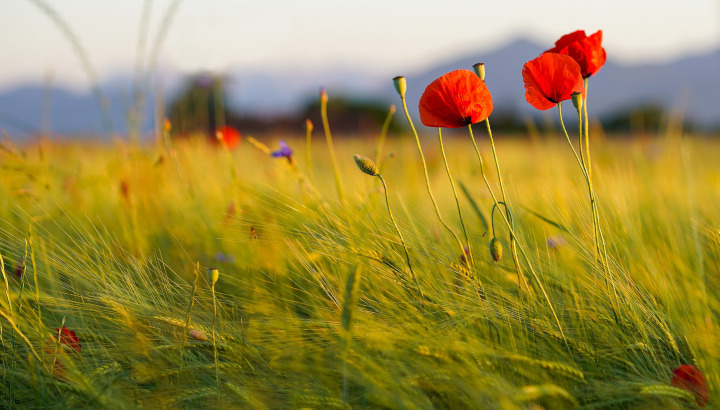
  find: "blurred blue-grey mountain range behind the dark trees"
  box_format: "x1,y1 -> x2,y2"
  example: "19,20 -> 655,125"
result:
0,39 -> 720,135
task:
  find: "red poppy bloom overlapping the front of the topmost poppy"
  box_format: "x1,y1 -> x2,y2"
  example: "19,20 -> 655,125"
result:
523,53 -> 583,110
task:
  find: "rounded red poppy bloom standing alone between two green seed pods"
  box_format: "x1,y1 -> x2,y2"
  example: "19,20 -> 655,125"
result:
419,70 -> 492,128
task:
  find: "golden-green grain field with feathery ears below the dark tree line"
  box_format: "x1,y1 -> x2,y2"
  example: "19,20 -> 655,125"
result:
0,131 -> 720,409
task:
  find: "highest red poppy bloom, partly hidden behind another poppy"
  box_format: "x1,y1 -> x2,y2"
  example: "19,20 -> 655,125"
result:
546,30 -> 607,78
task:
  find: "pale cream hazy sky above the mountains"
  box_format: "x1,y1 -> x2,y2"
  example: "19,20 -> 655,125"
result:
0,0 -> 720,89
